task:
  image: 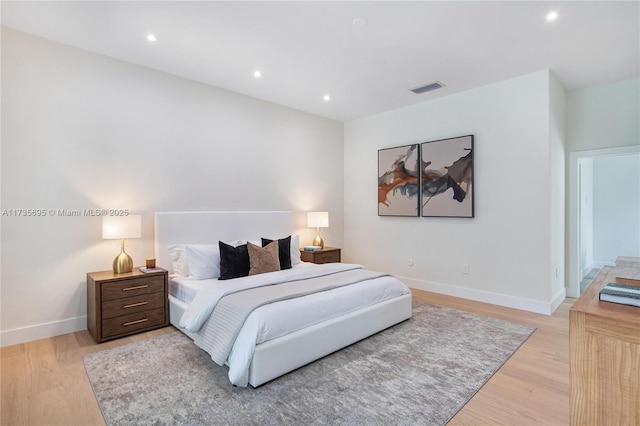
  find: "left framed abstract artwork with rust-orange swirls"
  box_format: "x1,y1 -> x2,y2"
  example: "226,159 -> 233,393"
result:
378,144 -> 420,217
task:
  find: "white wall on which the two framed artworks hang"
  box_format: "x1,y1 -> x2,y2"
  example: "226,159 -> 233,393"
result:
344,71 -> 564,313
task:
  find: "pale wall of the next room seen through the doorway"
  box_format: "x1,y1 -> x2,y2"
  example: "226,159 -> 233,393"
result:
593,153 -> 640,265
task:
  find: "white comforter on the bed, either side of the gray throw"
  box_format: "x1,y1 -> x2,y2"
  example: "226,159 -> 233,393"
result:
180,263 -> 410,386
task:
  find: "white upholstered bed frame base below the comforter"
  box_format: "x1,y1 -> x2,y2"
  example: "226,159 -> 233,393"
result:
169,293 -> 411,387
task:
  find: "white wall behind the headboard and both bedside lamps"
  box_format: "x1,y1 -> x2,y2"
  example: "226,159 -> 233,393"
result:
0,28 -> 344,345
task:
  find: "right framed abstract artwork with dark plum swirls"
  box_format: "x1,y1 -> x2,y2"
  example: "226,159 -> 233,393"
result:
420,135 -> 474,217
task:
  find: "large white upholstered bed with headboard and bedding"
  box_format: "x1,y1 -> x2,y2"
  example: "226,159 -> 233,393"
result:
154,211 -> 411,387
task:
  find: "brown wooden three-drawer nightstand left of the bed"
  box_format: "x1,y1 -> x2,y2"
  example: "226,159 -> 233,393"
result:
87,268 -> 169,343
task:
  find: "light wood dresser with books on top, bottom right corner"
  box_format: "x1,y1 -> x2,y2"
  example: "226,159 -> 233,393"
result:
569,267 -> 640,426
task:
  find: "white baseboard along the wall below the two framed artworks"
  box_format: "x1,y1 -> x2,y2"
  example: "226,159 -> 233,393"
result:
397,276 -> 566,315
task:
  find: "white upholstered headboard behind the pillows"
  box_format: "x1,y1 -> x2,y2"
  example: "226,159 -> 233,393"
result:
154,211 -> 293,270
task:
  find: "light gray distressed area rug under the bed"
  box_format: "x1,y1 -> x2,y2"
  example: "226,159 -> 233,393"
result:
84,302 -> 534,425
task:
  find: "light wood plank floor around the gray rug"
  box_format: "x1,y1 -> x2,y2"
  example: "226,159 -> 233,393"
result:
0,290 -> 575,425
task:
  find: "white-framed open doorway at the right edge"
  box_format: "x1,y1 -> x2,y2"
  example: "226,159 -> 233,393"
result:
567,146 -> 640,297
